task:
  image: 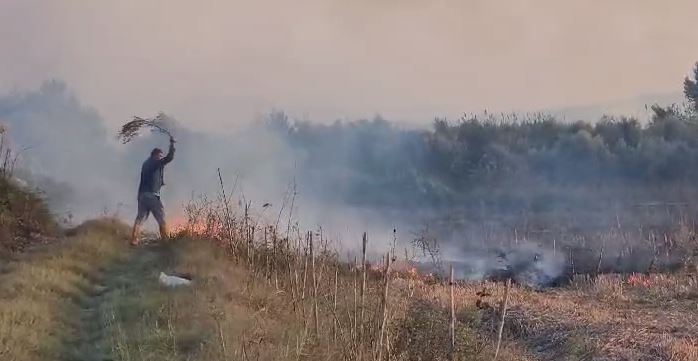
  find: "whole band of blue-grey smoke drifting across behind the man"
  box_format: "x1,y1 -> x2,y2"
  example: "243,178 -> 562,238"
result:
0,81 -> 698,285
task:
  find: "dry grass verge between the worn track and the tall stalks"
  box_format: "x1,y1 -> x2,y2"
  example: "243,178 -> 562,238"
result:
105,235 -> 384,361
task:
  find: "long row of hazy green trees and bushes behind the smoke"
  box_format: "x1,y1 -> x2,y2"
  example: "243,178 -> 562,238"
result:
270,107 -> 698,210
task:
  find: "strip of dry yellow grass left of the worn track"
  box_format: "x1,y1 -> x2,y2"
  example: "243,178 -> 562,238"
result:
0,217 -> 129,361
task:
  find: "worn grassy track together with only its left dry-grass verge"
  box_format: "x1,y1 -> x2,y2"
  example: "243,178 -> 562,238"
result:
0,220 -> 177,361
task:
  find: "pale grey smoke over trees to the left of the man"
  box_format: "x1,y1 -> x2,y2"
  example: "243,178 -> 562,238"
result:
0,81 -> 126,218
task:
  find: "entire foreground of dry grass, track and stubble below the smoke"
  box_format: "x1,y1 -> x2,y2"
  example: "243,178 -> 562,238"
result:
0,212 -> 698,361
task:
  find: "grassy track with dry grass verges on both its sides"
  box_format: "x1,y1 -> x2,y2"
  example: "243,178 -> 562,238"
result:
0,220 -> 348,361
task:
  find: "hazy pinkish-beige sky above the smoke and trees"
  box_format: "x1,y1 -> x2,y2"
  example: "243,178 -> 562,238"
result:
0,0 -> 698,128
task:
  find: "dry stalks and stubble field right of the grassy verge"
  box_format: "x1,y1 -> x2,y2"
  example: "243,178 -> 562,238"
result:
167,187 -> 698,360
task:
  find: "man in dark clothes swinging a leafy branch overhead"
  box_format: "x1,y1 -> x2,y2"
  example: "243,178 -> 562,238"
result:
131,136 -> 175,246
